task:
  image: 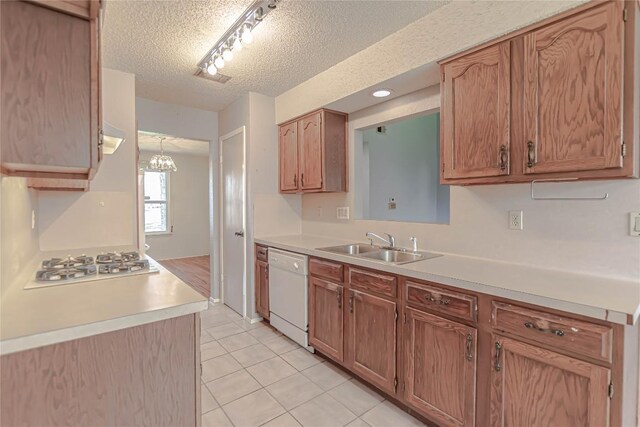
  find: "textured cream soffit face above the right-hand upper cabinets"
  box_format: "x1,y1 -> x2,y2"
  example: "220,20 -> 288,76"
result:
276,0 -> 586,123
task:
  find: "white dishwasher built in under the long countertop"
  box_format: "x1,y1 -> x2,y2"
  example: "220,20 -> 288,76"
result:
269,248 -> 314,352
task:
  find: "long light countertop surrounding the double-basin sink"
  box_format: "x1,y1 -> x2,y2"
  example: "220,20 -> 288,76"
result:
255,235 -> 640,325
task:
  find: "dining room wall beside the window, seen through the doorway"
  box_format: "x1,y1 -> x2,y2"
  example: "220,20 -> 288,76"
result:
140,151 -> 211,260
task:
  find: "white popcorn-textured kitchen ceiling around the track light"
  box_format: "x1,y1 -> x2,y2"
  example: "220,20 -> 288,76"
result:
103,0 -> 447,111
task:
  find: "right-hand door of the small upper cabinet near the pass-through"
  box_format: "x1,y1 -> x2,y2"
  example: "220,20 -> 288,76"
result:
298,112 -> 324,190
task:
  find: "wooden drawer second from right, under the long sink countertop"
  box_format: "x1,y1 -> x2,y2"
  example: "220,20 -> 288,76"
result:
405,280 -> 477,322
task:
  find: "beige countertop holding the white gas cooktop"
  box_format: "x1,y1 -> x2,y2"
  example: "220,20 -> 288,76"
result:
0,249 -> 208,355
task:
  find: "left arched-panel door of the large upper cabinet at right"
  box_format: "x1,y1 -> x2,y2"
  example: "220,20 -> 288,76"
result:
442,41 -> 511,179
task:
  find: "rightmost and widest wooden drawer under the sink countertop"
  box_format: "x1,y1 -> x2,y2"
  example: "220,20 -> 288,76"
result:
491,301 -> 613,362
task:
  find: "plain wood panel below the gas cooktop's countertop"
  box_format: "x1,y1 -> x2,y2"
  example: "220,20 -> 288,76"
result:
0,314 -> 201,426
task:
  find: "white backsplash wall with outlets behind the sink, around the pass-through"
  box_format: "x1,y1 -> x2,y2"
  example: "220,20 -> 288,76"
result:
302,87 -> 640,280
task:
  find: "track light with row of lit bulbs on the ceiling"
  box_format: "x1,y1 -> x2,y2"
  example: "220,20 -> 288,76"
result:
198,0 -> 281,76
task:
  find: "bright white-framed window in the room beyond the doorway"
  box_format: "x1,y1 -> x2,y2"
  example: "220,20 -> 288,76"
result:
144,171 -> 171,234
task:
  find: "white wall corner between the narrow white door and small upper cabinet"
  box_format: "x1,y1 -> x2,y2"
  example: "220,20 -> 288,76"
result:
214,92 -> 302,318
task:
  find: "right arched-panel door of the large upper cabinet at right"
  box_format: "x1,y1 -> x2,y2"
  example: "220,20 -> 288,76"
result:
524,1 -> 624,173
